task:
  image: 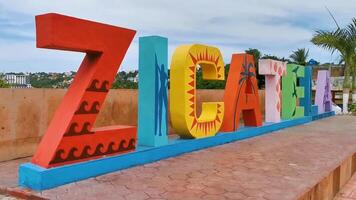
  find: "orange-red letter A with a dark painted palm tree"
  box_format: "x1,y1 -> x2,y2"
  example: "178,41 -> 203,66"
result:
221,54 -> 262,132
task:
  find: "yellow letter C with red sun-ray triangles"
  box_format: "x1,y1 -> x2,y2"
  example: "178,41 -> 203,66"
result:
170,44 -> 225,138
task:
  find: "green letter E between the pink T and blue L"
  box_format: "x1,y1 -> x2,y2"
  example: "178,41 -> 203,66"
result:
282,64 -> 304,120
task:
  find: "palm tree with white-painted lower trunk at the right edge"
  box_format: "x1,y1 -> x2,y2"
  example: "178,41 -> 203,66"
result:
311,23 -> 356,113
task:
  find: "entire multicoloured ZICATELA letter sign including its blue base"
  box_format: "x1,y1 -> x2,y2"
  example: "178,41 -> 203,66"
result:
18,13 -> 340,190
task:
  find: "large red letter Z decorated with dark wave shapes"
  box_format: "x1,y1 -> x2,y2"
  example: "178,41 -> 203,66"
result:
32,13 -> 136,168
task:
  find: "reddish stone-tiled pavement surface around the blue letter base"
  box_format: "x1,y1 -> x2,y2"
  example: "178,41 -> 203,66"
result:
0,116 -> 356,200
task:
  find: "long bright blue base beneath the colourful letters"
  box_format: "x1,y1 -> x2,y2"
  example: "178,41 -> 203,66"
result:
18,112 -> 335,190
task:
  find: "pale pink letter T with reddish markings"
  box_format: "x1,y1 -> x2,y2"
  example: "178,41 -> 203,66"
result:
258,59 -> 287,122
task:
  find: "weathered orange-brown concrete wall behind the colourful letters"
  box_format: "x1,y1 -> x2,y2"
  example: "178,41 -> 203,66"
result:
0,89 -> 264,161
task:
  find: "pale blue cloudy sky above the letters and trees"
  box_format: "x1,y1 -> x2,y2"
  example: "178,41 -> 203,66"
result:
0,0 -> 356,72
